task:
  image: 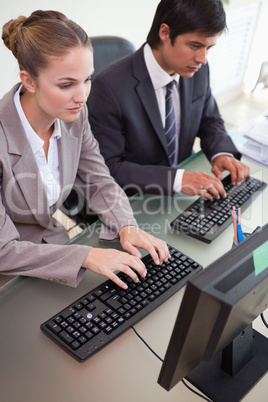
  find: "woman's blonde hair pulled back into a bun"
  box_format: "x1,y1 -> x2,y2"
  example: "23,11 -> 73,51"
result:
2,10 -> 92,78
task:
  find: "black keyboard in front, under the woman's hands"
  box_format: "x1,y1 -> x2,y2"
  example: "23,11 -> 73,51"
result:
41,246 -> 202,362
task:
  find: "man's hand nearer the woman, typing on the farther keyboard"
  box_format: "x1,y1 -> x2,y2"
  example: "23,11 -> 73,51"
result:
181,172 -> 226,200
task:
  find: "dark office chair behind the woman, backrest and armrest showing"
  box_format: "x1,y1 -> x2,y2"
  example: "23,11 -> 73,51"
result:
60,36 -> 135,228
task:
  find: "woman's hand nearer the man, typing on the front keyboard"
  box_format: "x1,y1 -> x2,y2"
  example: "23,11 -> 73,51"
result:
119,226 -> 170,265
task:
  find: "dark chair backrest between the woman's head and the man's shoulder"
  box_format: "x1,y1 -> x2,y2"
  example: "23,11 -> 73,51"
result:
90,36 -> 135,79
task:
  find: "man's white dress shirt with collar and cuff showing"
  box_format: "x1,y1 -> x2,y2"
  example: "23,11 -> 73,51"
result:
144,43 -> 184,193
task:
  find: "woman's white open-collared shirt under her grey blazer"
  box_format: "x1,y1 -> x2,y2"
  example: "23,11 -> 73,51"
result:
14,85 -> 61,207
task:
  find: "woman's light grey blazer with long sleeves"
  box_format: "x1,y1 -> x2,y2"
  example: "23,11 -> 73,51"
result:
0,84 -> 136,286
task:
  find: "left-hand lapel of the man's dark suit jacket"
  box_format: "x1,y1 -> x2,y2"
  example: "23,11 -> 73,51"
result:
133,46 -> 168,157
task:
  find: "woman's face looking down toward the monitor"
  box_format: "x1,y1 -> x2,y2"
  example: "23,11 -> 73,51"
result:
29,47 -> 94,122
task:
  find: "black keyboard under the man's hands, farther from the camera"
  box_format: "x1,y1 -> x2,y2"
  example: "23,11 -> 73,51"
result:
171,175 -> 266,243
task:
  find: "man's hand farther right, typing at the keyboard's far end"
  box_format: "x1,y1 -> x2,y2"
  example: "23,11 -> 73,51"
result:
211,155 -> 249,184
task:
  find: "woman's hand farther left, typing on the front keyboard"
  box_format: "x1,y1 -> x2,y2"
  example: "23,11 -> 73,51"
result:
82,248 -> 146,289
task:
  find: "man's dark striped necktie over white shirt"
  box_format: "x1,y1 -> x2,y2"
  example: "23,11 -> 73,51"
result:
165,80 -> 177,166
